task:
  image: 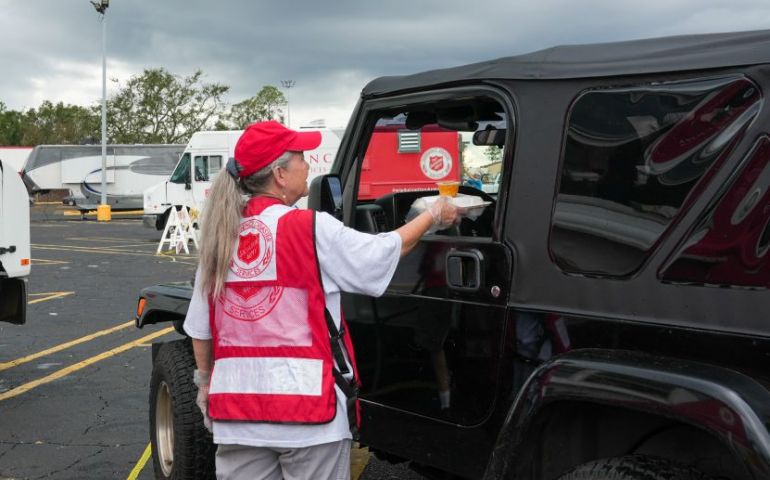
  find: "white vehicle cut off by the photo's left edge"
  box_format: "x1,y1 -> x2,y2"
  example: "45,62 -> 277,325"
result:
0,160 -> 31,325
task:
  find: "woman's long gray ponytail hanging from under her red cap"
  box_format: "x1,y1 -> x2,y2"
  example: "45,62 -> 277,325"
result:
199,152 -> 292,298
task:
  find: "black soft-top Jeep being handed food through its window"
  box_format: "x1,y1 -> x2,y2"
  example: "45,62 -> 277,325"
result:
137,31 -> 770,480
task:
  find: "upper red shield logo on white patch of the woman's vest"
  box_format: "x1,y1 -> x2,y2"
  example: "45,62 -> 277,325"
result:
230,218 -> 274,278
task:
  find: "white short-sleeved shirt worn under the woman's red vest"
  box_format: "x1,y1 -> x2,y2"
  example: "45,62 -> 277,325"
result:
184,210 -> 401,448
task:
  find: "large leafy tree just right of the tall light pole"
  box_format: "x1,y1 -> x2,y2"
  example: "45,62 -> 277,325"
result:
107,68 -> 230,143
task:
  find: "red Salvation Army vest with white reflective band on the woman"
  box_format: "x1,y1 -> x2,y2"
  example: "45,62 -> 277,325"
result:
209,197 -> 358,428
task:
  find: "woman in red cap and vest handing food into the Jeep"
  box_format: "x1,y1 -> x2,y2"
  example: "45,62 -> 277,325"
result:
184,121 -> 458,480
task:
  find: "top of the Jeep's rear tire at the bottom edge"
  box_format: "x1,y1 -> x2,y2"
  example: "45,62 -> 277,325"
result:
559,455 -> 709,480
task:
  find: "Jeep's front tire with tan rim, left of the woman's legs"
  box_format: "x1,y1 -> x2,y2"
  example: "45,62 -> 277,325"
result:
150,339 -> 216,480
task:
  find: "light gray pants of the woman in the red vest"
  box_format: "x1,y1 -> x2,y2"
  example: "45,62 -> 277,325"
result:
216,440 -> 350,480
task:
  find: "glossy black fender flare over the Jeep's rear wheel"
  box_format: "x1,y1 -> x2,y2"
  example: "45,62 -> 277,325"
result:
483,349 -> 770,480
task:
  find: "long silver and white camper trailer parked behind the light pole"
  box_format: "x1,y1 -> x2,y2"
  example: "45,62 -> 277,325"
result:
22,145 -> 184,210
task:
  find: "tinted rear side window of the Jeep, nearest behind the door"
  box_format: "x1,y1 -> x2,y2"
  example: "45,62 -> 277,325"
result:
549,75 -> 762,276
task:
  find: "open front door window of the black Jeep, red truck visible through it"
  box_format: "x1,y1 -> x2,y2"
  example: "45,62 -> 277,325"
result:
356,98 -> 507,237
